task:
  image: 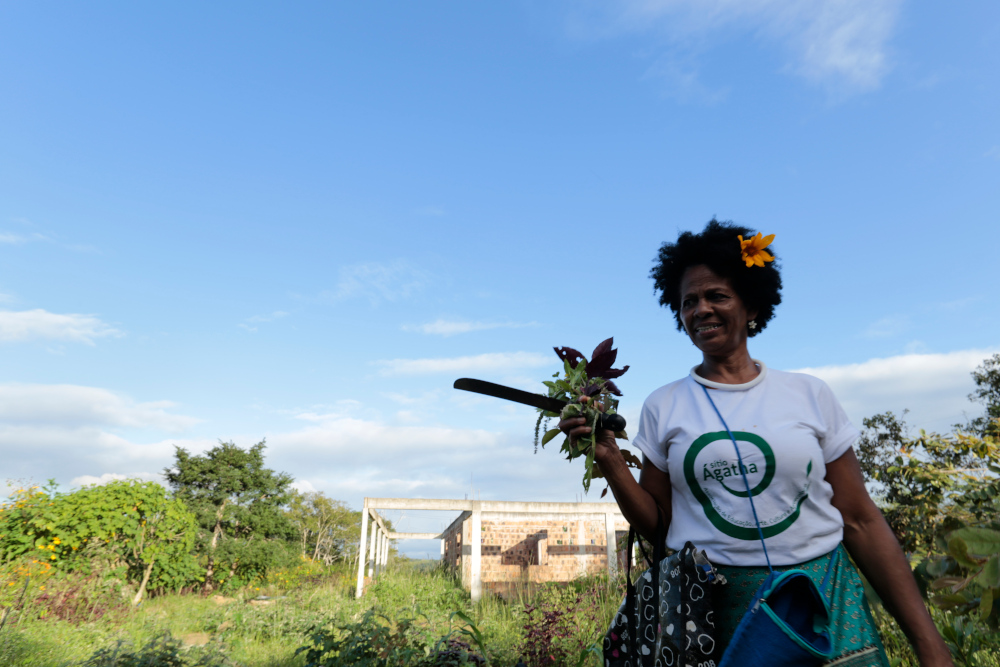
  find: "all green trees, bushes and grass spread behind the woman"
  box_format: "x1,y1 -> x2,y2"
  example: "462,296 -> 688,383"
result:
0,355 -> 1000,667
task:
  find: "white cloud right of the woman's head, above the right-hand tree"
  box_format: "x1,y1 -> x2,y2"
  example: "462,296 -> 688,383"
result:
799,350 -> 997,432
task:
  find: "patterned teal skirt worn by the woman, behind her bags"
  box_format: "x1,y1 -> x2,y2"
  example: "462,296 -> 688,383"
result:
713,544 -> 889,667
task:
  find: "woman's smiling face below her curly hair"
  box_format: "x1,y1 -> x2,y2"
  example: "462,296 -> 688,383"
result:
680,264 -> 756,357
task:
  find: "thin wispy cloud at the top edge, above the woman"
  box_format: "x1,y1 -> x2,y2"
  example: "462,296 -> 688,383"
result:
580,0 -> 902,91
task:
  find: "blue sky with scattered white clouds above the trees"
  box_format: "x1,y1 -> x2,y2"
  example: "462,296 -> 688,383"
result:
0,0 -> 1000,553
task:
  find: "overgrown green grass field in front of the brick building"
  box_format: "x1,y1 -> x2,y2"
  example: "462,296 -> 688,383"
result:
0,562 -> 1000,667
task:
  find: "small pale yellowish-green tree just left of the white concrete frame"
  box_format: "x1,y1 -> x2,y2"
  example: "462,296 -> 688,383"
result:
286,491 -> 361,565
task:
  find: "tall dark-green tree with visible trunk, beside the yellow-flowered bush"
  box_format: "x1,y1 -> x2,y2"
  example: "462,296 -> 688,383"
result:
164,440 -> 296,591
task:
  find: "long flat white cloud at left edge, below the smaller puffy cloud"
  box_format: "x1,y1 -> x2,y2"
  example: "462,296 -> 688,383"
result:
0,383 -> 201,433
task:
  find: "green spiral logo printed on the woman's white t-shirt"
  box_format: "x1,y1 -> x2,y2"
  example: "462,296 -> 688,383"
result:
684,431 -> 812,540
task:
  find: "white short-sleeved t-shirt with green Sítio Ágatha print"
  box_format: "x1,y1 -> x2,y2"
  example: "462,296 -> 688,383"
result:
632,361 -> 859,566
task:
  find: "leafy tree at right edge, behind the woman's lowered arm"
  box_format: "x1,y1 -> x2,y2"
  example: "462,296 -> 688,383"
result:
858,355 -> 1000,628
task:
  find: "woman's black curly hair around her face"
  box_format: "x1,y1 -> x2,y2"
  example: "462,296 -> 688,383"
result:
649,218 -> 781,336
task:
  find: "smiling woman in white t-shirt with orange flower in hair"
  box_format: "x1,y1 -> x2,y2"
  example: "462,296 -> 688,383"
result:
559,220 -> 952,667
